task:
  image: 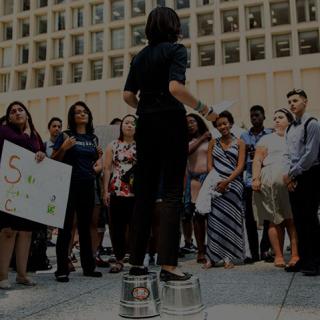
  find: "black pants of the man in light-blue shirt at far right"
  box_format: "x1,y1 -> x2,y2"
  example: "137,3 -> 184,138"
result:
289,165 -> 320,265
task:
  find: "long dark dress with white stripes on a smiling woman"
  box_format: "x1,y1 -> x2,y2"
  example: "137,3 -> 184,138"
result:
207,138 -> 244,264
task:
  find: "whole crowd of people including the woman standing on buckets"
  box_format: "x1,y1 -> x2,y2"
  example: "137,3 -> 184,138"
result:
0,7 -> 320,289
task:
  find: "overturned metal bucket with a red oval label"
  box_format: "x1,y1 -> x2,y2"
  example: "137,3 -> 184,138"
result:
119,272 -> 160,319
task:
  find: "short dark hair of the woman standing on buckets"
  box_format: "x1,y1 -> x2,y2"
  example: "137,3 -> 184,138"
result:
145,7 -> 181,45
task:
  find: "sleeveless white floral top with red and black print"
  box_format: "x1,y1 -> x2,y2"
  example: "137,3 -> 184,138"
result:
109,140 -> 137,197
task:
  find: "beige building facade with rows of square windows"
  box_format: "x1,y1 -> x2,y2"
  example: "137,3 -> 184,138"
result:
0,0 -> 320,134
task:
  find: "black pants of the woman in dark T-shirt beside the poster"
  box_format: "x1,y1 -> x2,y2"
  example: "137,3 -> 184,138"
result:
56,180 -> 95,274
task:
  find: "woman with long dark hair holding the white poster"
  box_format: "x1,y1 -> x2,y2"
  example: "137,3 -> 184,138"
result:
0,101 -> 45,289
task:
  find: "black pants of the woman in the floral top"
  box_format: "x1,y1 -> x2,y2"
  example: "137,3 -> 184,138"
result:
109,196 -> 135,260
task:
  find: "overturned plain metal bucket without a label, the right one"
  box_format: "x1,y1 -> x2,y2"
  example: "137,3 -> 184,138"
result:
161,277 -> 206,320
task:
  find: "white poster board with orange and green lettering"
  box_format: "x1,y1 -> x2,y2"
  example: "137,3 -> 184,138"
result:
0,140 -> 72,228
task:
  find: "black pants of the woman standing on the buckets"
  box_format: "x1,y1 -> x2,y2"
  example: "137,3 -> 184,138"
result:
130,112 -> 188,266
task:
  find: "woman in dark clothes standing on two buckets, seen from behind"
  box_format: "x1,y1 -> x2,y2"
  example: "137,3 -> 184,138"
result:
123,7 -> 217,281
